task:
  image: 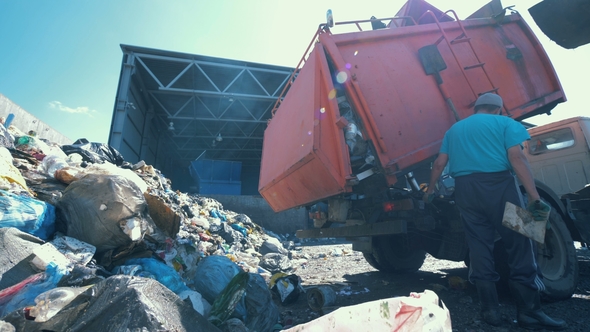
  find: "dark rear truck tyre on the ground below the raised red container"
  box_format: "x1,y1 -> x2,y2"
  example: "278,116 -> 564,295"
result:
363,235 -> 426,274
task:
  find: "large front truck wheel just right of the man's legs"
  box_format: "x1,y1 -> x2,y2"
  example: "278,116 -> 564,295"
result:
535,209 -> 578,301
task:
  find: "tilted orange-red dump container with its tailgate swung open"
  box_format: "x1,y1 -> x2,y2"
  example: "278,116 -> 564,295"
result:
259,2 -> 565,211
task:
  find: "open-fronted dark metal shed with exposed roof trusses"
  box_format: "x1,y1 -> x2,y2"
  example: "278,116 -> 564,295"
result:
109,45 -> 294,194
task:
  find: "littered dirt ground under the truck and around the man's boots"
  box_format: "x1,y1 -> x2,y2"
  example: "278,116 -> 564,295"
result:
277,242 -> 590,332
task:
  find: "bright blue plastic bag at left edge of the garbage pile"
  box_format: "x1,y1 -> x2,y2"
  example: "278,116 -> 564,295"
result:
0,190 -> 55,241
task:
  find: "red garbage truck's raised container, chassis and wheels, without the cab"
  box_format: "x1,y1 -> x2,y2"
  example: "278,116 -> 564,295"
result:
259,0 -> 590,300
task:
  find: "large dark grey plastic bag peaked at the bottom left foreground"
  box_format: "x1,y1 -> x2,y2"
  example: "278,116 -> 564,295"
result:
4,275 -> 220,332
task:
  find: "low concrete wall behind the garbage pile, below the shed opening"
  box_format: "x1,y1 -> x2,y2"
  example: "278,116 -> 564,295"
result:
207,195 -> 307,235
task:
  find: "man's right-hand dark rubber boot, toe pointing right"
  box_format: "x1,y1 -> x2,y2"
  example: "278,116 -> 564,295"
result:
509,281 -> 567,331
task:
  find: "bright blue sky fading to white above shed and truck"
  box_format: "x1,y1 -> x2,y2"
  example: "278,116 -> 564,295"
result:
0,0 -> 590,143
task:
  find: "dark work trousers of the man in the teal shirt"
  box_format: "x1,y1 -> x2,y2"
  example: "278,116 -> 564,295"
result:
455,171 -> 545,290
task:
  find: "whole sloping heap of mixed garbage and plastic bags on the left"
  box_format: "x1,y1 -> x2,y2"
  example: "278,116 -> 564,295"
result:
0,120 -> 302,331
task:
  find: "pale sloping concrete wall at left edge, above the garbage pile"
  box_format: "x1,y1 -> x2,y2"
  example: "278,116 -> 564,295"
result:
0,93 -> 73,145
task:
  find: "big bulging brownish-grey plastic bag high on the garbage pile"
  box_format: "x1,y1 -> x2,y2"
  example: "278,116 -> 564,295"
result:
58,174 -> 157,254
